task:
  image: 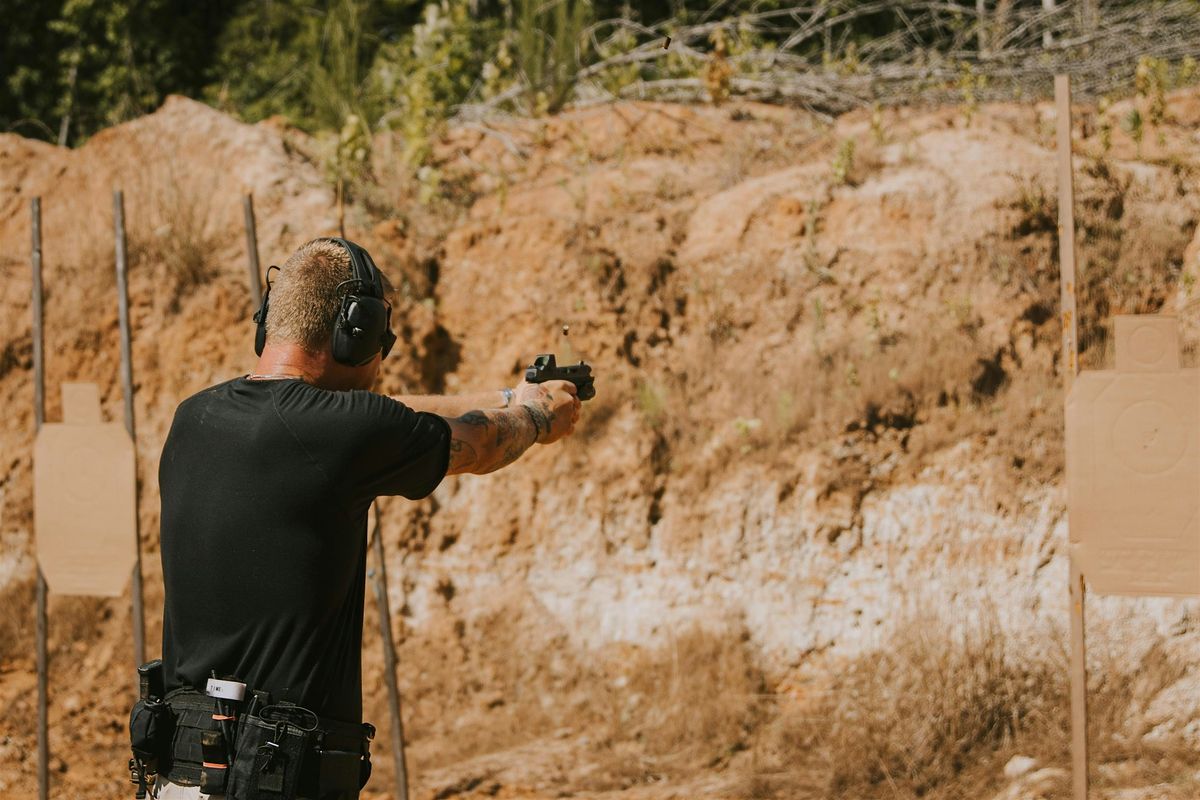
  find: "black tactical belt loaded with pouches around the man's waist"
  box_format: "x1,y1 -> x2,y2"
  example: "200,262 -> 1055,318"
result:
161,688 -> 374,800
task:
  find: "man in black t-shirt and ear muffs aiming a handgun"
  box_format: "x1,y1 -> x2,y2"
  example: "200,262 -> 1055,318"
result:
138,239 -> 590,800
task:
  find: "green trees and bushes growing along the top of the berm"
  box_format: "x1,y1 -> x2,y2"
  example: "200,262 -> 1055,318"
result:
9,0 -> 1198,153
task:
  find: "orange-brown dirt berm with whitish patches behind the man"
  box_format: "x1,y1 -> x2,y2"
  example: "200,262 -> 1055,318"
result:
0,92 -> 1200,798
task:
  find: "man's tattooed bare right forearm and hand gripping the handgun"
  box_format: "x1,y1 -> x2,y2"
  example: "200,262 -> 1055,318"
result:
446,380 -> 580,475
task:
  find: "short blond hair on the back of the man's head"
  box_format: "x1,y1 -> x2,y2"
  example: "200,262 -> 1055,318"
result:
266,239 -> 353,351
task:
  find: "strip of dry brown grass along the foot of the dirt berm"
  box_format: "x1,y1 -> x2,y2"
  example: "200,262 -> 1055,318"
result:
406,603 -> 1194,800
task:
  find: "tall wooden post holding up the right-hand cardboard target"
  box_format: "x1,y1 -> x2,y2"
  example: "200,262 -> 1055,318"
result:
1054,76 -> 1088,800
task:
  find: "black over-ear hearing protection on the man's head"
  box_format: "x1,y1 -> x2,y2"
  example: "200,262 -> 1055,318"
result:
254,236 -> 396,367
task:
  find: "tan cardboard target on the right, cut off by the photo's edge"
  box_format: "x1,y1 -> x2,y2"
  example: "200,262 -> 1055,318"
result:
1067,315 -> 1200,596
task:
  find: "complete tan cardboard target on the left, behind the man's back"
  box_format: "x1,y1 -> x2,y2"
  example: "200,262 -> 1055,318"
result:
34,384 -> 137,597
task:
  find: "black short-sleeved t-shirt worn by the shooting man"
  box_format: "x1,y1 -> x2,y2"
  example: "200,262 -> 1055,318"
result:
158,378 -> 450,722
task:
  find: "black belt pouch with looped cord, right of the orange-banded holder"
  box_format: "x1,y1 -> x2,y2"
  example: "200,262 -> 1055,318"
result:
228,715 -> 310,800
